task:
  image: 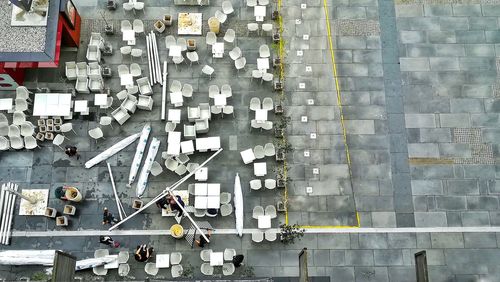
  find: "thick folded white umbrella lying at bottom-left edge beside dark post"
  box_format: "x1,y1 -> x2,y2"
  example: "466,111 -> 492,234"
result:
0,250 -> 56,265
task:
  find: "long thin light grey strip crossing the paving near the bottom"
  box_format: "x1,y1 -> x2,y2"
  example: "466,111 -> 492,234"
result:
12,226 -> 500,237
